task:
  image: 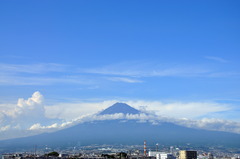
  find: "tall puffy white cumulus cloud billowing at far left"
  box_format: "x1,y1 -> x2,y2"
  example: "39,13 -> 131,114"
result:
0,91 -> 60,138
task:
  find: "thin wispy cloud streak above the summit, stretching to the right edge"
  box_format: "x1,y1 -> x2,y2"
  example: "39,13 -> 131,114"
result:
82,60 -> 240,81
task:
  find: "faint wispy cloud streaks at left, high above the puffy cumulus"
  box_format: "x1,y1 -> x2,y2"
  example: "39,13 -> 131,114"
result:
0,63 -> 95,85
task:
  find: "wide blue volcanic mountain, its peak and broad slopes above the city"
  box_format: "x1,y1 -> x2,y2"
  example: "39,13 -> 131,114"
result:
0,103 -> 240,151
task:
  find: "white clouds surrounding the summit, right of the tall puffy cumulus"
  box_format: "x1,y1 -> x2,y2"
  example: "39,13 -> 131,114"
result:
41,100 -> 240,133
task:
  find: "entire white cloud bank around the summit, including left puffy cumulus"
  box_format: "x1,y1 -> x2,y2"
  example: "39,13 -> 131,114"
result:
0,91 -> 240,139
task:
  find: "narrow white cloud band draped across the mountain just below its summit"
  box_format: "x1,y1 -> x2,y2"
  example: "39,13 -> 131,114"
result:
29,113 -> 240,134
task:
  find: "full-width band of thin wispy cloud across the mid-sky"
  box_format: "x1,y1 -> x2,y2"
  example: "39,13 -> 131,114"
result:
0,60 -> 239,86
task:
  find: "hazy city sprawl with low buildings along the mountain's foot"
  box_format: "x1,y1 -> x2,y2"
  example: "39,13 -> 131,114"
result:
2,141 -> 240,159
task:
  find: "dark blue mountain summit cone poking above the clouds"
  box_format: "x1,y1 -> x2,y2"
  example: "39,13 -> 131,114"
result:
98,103 -> 141,115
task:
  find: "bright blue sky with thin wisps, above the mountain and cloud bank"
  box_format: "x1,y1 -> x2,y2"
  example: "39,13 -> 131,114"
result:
0,0 -> 240,138
